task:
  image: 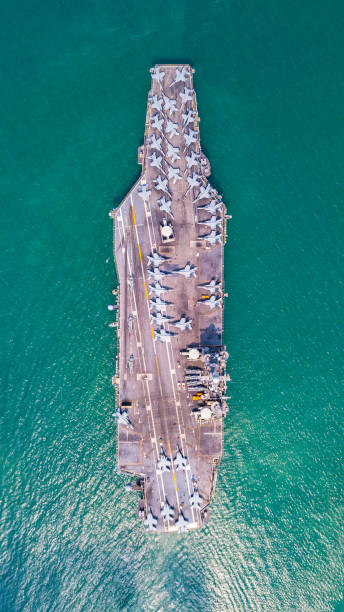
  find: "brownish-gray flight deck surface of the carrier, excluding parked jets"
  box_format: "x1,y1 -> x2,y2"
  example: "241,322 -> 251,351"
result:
111,65 -> 227,531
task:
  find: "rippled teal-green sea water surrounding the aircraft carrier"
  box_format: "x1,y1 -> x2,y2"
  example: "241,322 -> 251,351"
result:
0,0 -> 344,612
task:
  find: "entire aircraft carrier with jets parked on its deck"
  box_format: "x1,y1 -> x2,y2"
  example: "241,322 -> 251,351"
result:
109,65 -> 228,532
